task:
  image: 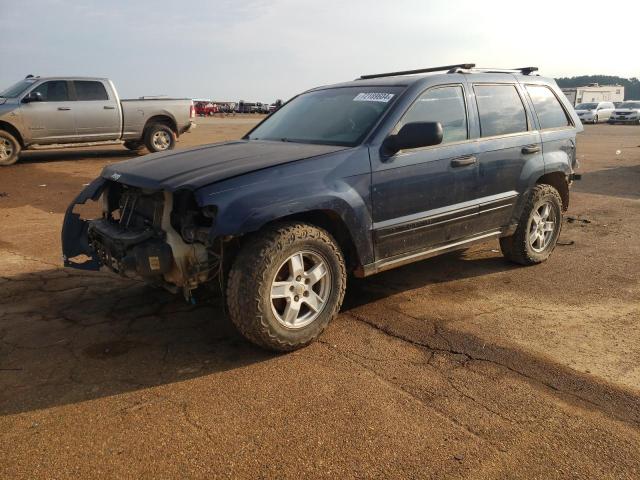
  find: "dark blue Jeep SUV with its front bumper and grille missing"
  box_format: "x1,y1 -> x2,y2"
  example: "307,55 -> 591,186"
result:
62,64 -> 582,351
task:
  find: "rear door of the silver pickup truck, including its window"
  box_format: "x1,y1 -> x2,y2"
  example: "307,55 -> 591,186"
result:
73,80 -> 122,142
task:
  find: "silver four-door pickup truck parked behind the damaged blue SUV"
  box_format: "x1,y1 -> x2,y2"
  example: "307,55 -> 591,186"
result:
0,76 -> 195,166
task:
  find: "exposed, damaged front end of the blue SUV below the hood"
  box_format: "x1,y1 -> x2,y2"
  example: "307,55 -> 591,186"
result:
62,178 -> 222,299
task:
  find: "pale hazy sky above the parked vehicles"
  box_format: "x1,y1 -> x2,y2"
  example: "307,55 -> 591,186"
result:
0,0 -> 640,102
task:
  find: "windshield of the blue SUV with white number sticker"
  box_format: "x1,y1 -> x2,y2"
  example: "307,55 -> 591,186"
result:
245,86 -> 402,147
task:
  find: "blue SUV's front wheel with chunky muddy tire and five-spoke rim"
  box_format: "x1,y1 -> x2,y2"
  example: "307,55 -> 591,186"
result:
227,223 -> 347,352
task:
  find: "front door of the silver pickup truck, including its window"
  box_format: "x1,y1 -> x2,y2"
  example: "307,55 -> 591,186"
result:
20,80 -> 76,144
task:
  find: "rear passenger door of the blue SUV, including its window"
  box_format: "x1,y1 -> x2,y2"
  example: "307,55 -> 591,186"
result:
473,82 -> 544,232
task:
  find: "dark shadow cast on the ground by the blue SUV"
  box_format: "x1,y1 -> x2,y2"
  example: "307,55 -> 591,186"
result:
0,254 -> 512,414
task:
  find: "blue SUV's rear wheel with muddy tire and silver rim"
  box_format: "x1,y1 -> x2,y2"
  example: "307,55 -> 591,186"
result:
500,184 -> 562,265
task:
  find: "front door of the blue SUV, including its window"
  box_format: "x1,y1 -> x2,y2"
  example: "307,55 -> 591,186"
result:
371,84 -> 478,260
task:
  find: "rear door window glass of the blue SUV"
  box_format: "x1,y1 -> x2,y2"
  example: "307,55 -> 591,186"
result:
473,85 -> 527,137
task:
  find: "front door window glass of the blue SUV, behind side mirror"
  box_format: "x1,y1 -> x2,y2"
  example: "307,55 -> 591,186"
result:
396,86 -> 467,143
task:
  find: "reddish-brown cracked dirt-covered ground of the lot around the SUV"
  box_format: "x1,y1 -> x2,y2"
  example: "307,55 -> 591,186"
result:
0,116 -> 640,479
